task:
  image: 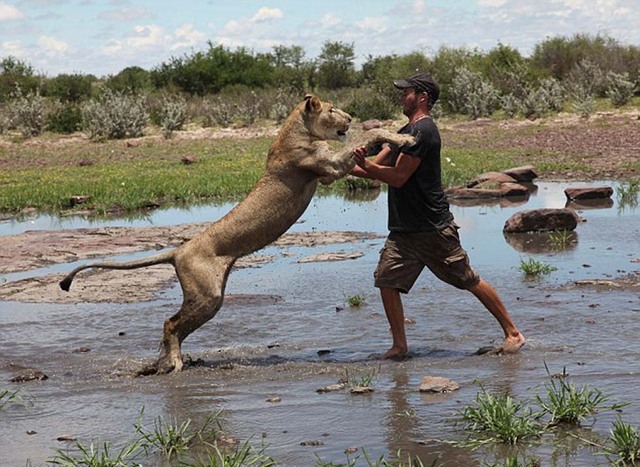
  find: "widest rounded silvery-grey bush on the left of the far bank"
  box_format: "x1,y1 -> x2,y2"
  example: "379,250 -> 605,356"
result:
82,88 -> 149,141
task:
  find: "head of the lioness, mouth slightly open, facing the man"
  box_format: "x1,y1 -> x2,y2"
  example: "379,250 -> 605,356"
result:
300,94 -> 351,142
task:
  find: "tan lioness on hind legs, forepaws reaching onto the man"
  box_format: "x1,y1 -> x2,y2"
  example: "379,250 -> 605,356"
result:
60,95 -> 414,374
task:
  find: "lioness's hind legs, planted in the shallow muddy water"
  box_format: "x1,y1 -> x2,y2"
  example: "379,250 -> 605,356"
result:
143,256 -> 235,373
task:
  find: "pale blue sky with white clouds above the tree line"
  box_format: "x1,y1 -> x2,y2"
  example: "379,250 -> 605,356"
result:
0,0 -> 640,76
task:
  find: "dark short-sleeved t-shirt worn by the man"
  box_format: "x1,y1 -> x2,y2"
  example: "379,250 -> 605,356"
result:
388,117 -> 453,232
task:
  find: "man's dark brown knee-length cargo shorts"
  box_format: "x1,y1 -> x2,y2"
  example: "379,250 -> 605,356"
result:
374,222 -> 480,293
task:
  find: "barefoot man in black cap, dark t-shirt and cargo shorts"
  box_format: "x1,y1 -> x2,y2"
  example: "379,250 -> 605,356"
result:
351,72 -> 525,359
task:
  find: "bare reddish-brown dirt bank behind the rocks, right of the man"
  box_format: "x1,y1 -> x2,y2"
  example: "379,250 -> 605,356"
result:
441,109 -> 640,181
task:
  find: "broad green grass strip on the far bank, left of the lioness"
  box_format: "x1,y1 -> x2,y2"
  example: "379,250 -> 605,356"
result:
0,138 -> 270,213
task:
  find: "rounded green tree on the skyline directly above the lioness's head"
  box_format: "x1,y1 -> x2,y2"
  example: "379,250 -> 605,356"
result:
318,41 -> 356,89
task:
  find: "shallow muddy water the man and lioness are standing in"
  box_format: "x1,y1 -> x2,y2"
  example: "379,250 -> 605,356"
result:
0,183 -> 640,466
